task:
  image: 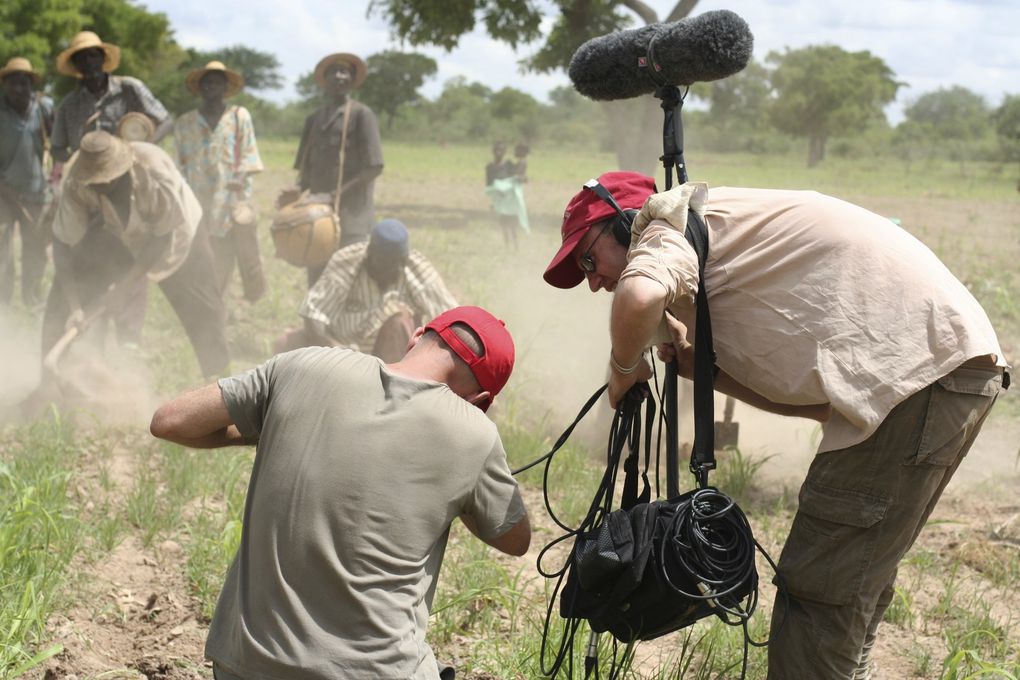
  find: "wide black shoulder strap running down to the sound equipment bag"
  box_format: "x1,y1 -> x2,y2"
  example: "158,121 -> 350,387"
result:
683,210 -> 715,487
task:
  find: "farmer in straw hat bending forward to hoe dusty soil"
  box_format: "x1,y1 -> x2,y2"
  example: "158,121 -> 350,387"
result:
43,130 -> 230,376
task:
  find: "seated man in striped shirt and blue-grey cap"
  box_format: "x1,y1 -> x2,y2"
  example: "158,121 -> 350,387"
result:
274,219 -> 457,361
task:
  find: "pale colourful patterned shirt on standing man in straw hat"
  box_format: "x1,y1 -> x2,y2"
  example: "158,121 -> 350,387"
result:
173,106 -> 263,237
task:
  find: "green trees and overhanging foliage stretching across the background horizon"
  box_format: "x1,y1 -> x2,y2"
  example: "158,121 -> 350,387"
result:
0,0 -> 1020,170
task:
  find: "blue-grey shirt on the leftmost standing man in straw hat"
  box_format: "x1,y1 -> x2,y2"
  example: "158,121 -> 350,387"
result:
0,96 -> 53,203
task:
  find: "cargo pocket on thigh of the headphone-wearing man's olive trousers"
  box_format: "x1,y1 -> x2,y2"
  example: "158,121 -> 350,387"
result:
773,482 -> 889,605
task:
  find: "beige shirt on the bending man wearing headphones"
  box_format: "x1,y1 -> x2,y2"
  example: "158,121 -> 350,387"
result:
621,184 -> 1005,452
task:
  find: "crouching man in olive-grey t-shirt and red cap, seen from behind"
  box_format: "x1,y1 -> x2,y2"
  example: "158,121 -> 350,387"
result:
151,307 -> 530,680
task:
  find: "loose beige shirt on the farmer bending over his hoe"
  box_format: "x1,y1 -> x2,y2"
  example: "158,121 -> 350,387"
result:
53,142 -> 202,281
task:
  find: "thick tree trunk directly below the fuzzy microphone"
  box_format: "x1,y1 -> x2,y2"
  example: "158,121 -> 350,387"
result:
602,95 -> 662,175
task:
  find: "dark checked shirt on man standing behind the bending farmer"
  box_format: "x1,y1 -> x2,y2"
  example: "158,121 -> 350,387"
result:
53,75 -> 170,151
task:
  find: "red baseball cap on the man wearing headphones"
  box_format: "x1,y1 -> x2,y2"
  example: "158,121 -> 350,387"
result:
543,172 -> 656,289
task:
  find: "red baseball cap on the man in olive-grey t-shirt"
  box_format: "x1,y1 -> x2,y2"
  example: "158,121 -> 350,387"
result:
425,307 -> 514,411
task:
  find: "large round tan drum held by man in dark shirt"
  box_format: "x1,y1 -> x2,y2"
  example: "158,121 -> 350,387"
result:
271,200 -> 340,267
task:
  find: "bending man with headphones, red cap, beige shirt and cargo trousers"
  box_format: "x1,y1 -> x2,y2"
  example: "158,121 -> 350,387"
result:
545,172 -> 1009,679
